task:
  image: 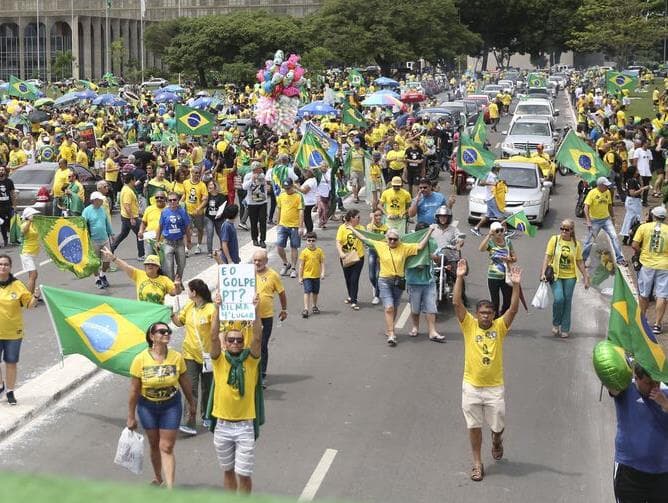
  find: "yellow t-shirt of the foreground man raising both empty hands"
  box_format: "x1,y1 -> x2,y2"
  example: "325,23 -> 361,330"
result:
459,312 -> 508,387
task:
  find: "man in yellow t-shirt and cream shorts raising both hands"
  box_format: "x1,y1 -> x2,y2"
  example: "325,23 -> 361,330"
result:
452,260 -> 522,482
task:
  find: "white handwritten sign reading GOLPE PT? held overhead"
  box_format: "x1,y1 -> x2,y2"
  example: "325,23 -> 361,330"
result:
218,264 -> 255,321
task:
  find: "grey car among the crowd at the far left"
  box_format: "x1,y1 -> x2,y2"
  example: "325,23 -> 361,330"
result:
9,162 -> 102,215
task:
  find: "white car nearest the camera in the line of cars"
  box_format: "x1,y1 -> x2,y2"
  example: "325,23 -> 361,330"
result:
468,161 -> 552,225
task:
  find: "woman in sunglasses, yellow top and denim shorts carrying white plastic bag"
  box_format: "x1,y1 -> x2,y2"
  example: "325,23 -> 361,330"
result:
126,321 -> 196,489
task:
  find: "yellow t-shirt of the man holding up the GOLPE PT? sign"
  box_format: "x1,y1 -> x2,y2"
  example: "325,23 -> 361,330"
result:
212,353 -> 260,421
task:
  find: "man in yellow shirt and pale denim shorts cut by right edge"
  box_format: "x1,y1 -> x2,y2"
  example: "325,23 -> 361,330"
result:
631,206 -> 668,335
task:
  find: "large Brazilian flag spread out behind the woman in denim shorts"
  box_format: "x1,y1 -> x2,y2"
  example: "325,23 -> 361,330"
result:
40,286 -> 172,376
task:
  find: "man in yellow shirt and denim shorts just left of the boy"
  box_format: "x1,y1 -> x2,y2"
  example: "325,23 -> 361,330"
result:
276,178 -> 304,278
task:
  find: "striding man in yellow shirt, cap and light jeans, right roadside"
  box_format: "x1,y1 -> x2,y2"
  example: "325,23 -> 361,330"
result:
582,176 -> 626,266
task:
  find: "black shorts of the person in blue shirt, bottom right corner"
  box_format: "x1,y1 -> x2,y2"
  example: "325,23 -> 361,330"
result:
614,463 -> 668,503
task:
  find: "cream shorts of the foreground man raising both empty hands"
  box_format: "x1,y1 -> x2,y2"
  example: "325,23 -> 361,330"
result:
462,382 -> 506,433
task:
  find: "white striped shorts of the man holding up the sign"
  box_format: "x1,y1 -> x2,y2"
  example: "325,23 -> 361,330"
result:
213,419 -> 255,477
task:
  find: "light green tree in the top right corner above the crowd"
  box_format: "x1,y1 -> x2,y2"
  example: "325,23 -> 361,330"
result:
568,0 -> 666,67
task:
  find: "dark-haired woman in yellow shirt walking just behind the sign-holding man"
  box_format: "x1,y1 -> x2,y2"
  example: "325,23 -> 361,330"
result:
172,279 -> 218,435
